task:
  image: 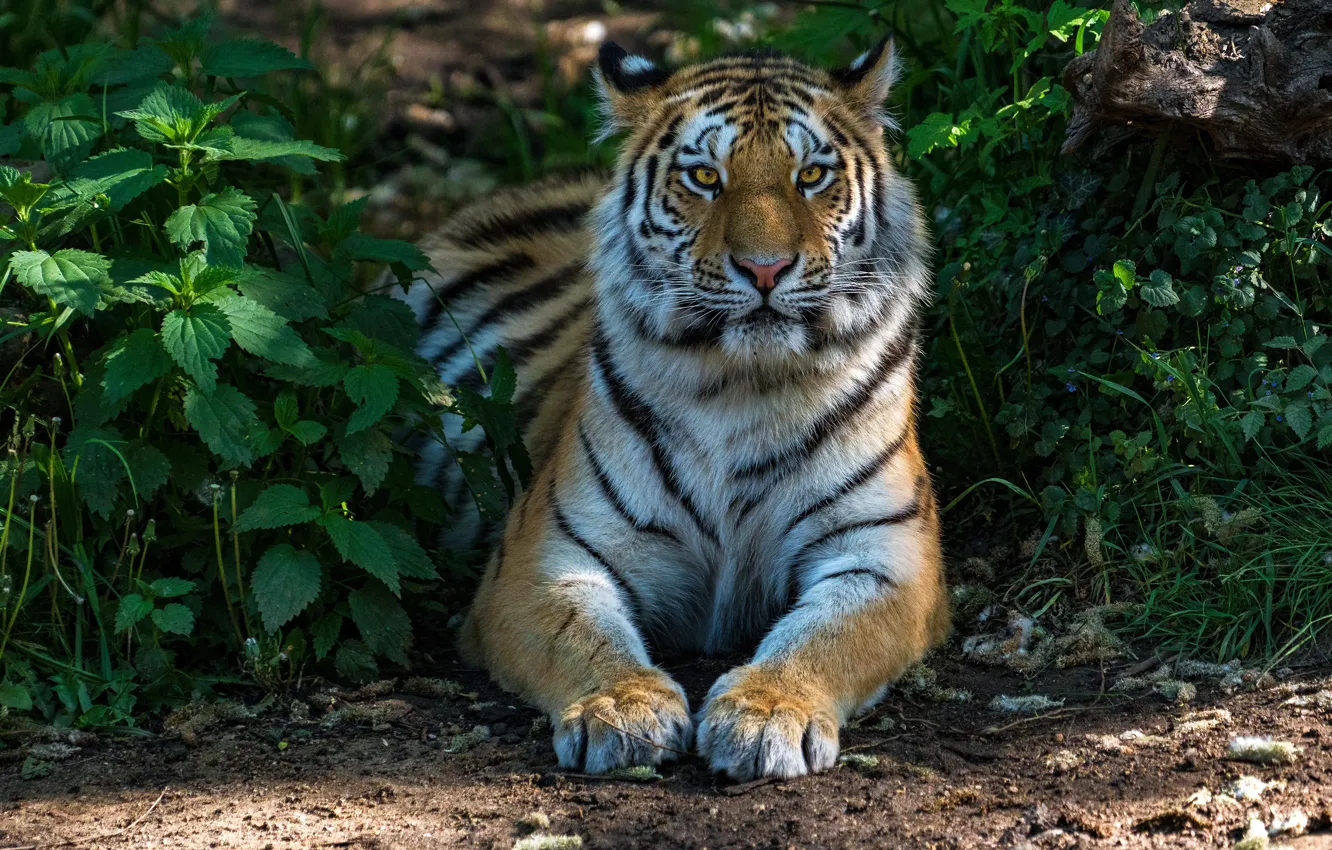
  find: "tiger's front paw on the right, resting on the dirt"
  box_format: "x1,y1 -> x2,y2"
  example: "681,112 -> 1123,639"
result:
698,666 -> 838,781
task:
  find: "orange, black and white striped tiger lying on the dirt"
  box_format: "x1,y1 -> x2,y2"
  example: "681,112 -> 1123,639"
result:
404,40 -> 950,781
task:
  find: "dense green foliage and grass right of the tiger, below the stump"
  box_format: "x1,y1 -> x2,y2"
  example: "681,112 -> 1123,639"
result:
787,0 -> 1332,657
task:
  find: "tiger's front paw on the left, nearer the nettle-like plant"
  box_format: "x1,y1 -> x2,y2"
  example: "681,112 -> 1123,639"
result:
555,669 -> 694,773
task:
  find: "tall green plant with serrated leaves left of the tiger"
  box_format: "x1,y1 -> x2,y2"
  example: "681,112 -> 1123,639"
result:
0,20 -> 526,725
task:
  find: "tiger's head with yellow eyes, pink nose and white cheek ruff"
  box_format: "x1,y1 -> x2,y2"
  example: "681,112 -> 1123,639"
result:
594,40 -> 927,362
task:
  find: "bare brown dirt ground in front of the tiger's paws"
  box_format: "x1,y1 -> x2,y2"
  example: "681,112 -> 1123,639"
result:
0,651 -> 1332,850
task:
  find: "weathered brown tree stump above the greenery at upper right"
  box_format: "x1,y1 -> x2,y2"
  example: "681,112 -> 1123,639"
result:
1064,0 -> 1332,163
